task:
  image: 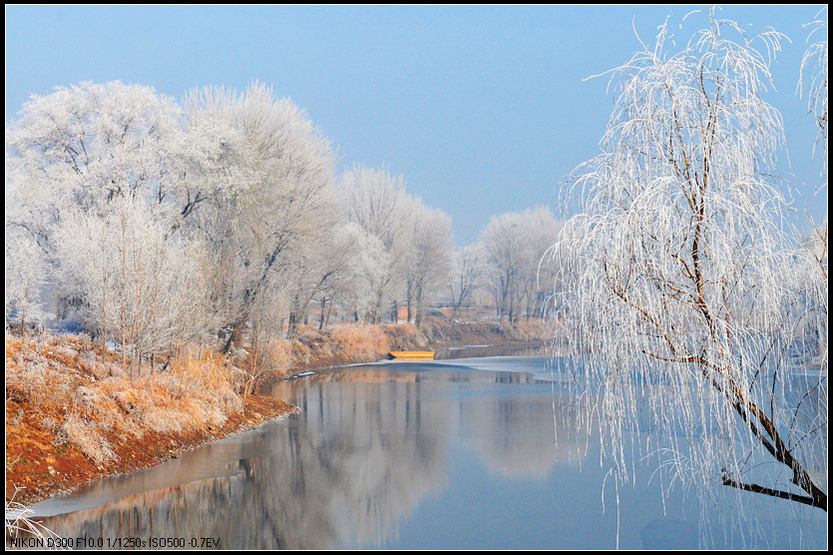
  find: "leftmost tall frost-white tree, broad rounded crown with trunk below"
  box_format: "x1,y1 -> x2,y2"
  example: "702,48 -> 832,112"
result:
6,81 -> 178,338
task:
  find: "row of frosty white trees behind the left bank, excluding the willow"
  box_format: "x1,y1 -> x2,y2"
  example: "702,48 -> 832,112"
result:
6,82 -> 560,370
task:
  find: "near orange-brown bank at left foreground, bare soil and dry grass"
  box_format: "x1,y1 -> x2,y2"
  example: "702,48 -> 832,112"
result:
5,334 -> 295,504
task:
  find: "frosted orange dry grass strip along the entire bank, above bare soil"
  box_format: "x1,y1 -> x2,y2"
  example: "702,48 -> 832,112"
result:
6,319 -> 544,470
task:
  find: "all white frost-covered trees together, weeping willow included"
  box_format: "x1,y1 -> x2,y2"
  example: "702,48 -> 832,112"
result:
5,5 -> 828,528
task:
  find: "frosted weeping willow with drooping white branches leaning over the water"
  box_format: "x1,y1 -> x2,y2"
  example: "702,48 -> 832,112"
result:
553,12 -> 827,511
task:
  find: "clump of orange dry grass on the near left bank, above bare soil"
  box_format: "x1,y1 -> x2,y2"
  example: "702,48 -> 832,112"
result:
6,334 -> 243,465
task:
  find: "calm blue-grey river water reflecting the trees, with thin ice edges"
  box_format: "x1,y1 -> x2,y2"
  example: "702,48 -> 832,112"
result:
22,356 -> 827,549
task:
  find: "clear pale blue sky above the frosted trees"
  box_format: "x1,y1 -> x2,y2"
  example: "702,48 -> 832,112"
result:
5,5 -> 827,245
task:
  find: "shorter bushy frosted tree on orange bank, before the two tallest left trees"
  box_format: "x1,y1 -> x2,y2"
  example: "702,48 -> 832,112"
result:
56,199 -> 217,369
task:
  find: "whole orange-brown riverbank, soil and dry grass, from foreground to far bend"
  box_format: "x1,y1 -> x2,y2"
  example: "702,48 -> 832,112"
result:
6,320 -> 545,510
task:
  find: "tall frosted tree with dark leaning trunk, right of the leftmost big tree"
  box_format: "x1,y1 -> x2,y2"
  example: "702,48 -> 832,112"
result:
179,83 -> 337,348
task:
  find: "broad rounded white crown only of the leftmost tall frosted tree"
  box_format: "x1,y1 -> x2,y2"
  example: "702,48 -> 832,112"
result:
6,81 -> 178,217
